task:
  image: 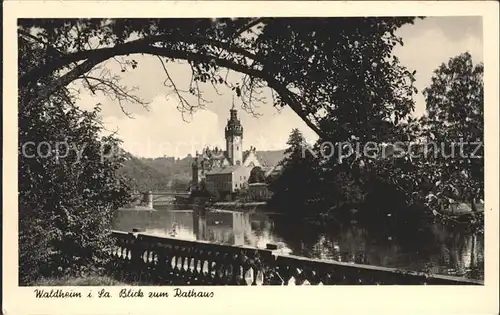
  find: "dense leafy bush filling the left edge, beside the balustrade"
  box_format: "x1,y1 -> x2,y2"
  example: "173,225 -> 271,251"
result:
18,38 -> 129,284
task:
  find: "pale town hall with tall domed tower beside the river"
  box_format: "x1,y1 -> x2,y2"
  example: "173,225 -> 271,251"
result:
192,103 -> 261,198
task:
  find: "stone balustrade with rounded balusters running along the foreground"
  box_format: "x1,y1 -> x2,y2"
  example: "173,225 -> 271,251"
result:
106,231 -> 483,285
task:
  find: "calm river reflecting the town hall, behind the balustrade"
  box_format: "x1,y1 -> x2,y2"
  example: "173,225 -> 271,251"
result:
113,207 -> 484,279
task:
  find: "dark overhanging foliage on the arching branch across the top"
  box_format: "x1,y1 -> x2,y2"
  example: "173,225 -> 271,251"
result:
19,17 -> 414,137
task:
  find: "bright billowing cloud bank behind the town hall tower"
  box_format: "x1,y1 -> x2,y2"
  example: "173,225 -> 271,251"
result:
77,90 -> 318,157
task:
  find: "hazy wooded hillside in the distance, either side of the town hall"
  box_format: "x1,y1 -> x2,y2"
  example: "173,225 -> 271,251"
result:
120,150 -> 284,191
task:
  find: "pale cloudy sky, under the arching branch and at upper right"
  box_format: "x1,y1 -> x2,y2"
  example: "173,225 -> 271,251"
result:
72,17 -> 483,158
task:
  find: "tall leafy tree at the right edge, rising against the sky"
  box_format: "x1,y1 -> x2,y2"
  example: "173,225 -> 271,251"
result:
422,53 -> 484,209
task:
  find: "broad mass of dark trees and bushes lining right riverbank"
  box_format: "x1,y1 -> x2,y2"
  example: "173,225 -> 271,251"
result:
270,53 -> 484,232
